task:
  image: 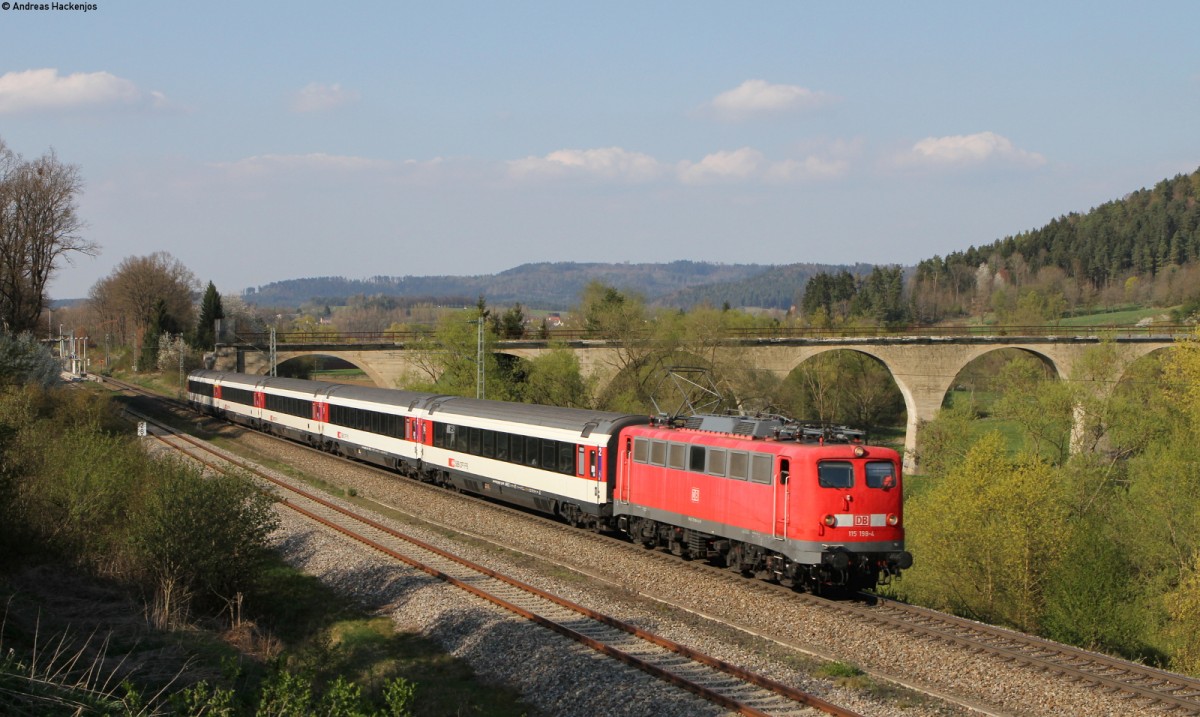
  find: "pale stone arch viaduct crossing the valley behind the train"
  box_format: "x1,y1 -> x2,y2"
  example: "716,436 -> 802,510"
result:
215,335 -> 1177,471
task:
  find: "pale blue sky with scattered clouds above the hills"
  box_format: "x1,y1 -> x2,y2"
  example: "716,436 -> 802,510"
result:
0,0 -> 1200,299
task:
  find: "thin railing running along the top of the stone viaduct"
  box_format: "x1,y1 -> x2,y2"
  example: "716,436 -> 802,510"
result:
229,324 -> 1196,347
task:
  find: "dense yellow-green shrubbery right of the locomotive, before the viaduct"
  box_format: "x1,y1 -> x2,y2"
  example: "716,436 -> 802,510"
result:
900,339 -> 1200,674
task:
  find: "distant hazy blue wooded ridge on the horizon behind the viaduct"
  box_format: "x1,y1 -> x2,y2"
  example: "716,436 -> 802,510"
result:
242,261 -> 777,309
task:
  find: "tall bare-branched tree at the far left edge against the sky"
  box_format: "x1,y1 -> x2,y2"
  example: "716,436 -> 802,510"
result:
0,140 -> 100,333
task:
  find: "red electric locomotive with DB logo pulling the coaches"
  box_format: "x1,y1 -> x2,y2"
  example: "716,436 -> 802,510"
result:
613,416 -> 912,592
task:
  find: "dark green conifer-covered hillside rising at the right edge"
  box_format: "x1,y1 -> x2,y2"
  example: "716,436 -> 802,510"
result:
917,170 -> 1200,289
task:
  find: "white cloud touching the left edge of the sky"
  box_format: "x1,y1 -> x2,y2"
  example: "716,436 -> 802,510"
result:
0,67 -> 149,114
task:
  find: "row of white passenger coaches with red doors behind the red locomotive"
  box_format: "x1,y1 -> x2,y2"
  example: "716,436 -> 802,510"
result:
188,370 -> 648,528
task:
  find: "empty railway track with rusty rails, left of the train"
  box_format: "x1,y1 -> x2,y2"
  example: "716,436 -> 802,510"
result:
121,398 -> 858,717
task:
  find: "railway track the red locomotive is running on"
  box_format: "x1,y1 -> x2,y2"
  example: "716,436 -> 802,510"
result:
100,376 -> 1200,715
